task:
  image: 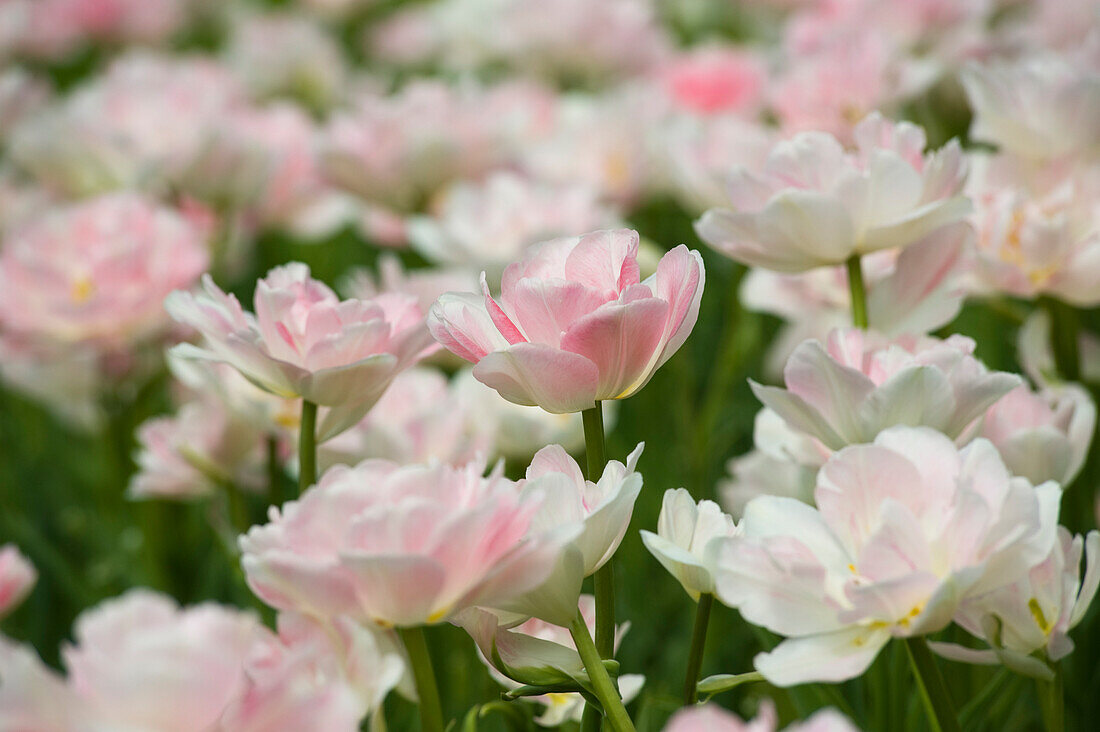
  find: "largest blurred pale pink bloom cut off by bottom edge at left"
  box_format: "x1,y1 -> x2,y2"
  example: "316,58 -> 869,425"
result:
62,589 -> 264,732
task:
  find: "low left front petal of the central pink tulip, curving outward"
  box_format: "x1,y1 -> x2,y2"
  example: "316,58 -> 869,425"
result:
473,343 -> 600,414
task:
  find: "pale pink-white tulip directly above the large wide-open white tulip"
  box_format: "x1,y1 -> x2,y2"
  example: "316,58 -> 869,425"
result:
750,328 -> 1022,450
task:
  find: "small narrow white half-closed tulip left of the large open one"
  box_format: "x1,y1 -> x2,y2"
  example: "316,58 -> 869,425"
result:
641,488 -> 737,601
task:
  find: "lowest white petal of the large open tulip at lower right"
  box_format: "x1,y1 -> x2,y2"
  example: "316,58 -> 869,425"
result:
752,625 -> 890,687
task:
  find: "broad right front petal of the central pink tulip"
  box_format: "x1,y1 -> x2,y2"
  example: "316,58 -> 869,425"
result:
561,297 -> 669,400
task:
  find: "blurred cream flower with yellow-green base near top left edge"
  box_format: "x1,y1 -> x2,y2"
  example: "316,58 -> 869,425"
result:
224,12 -> 348,111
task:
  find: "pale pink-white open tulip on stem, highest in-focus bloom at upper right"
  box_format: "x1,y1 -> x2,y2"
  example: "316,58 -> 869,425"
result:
695,114 -> 970,272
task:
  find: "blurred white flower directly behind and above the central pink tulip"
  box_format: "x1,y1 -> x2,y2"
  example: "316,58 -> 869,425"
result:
407,172 -> 619,281
